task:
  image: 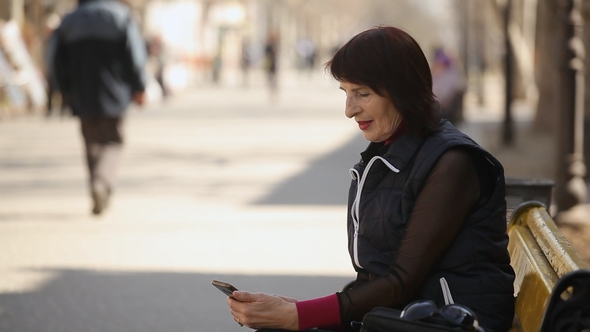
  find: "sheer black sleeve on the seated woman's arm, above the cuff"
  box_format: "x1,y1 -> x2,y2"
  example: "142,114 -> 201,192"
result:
338,149 -> 480,322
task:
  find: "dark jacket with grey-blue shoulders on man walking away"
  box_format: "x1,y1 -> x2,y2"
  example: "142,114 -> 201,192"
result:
52,0 -> 147,118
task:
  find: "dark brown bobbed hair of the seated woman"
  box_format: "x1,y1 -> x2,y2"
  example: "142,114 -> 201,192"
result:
325,26 -> 440,136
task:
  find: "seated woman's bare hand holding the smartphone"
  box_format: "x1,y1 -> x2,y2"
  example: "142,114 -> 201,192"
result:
227,291 -> 299,331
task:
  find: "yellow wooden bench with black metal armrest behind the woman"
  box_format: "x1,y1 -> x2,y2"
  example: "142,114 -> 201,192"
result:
508,201 -> 590,332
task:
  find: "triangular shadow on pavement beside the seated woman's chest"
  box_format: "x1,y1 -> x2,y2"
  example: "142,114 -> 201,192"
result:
253,134 -> 368,205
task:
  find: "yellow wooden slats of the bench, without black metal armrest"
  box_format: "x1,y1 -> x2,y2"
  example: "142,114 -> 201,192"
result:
508,201 -> 588,331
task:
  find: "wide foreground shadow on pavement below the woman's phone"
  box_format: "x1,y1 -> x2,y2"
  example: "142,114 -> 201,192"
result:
0,270 -> 350,332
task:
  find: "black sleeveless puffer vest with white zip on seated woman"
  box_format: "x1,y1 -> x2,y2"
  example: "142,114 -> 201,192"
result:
348,120 -> 514,331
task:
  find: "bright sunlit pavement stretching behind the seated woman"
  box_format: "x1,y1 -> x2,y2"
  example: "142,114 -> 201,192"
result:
0,68 -> 364,292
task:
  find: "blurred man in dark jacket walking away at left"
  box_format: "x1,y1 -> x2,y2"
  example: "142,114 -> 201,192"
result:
53,0 -> 147,214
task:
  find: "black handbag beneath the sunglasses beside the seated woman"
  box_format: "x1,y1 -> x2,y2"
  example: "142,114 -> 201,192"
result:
360,307 -> 474,332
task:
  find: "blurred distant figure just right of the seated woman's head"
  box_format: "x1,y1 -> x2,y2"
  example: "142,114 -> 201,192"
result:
432,48 -> 466,126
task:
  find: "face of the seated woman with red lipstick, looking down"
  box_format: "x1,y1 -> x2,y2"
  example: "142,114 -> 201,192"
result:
340,82 -> 403,142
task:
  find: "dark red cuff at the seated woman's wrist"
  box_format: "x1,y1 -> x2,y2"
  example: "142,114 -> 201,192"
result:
295,294 -> 340,330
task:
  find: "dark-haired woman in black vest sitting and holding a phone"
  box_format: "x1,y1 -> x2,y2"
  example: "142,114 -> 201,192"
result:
228,26 -> 514,331
